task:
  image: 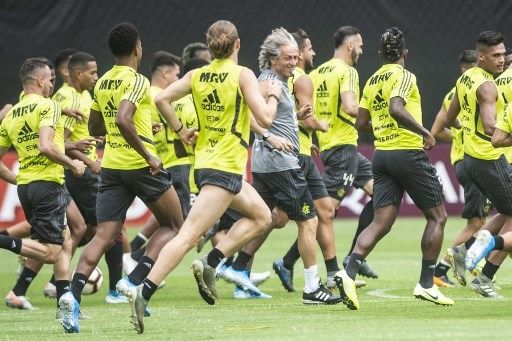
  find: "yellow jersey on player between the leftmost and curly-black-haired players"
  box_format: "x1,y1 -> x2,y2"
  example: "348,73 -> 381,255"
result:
52,83 -> 98,161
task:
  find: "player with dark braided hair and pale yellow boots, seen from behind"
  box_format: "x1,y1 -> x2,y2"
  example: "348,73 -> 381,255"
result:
340,27 -> 453,309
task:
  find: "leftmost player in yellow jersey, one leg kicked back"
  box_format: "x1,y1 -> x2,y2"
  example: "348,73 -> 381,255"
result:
0,58 -> 85,308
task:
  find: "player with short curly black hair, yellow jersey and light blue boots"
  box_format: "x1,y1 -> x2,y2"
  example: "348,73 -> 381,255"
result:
59,23 -> 183,333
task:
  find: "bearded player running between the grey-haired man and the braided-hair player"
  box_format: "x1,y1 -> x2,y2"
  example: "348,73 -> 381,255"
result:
309,26 -> 378,278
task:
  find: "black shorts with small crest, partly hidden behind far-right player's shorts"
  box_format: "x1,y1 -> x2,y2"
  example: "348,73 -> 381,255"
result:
454,159 -> 491,219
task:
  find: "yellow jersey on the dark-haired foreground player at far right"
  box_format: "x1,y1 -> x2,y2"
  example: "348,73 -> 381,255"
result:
456,66 -> 503,160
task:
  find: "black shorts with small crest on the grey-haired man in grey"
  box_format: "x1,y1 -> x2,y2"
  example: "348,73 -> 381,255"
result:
252,169 -> 316,221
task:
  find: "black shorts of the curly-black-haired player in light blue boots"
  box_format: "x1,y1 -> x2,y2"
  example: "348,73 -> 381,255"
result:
96,167 -> 172,223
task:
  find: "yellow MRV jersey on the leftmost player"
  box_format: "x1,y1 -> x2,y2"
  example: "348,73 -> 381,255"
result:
0,94 -> 64,185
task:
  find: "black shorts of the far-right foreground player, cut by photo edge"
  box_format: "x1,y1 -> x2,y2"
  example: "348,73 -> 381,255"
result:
464,154 -> 512,216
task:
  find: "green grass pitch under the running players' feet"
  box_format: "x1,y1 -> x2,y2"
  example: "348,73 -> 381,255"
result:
0,217 -> 512,340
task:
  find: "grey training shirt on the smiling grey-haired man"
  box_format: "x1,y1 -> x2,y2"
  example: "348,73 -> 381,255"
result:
251,69 -> 300,173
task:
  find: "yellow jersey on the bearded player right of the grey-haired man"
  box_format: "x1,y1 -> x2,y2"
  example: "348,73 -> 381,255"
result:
309,58 -> 359,151
